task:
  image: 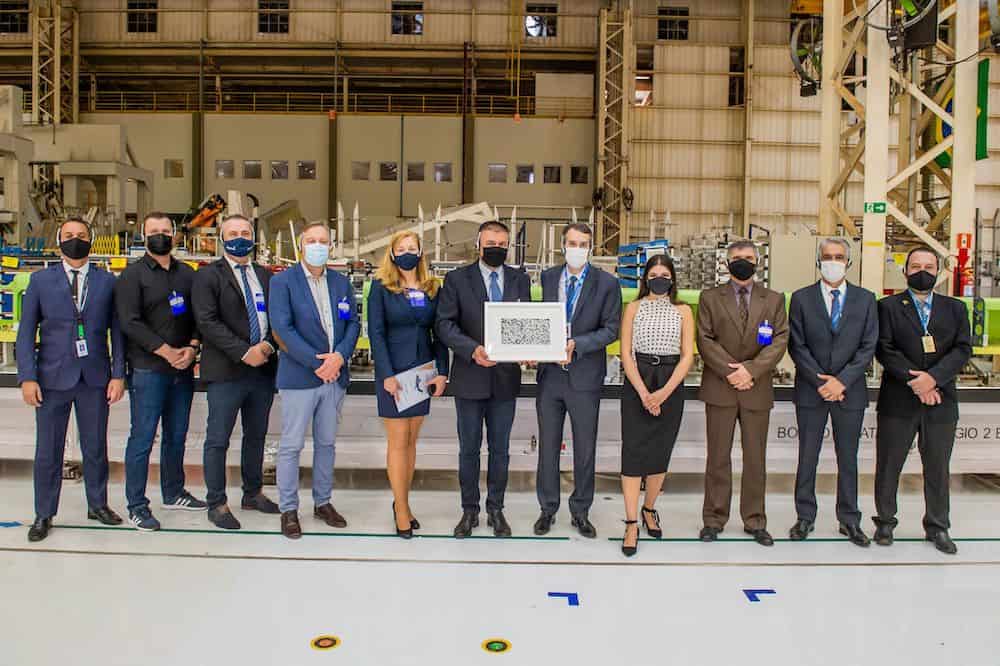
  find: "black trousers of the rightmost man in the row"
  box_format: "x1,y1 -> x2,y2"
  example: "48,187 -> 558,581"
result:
875,408 -> 958,534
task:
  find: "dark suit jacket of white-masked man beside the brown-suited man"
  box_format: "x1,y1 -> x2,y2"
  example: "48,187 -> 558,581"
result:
788,282 -> 878,409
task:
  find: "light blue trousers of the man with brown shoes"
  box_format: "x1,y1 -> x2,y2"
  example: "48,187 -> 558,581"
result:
277,382 -> 346,513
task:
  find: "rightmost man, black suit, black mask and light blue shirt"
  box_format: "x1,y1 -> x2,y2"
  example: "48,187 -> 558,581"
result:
874,246 -> 972,555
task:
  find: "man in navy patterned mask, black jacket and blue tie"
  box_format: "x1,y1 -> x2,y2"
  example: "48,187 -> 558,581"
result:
191,215 -> 278,530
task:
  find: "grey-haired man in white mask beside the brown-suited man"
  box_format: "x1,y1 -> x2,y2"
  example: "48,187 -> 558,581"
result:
788,238 -> 878,547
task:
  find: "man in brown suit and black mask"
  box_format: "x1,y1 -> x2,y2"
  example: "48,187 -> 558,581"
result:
698,241 -> 788,546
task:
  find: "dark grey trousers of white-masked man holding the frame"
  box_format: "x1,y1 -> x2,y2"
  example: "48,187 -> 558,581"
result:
535,368 -> 601,516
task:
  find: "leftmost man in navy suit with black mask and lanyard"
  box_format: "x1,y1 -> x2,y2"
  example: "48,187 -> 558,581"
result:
16,217 -> 125,541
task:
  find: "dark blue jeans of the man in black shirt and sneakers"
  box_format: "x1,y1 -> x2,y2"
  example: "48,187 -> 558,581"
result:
125,368 -> 194,514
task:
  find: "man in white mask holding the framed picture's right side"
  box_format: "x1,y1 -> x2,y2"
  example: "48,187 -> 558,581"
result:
535,224 -> 622,538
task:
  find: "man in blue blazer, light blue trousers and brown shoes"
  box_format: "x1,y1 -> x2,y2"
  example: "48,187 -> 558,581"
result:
270,222 -> 361,539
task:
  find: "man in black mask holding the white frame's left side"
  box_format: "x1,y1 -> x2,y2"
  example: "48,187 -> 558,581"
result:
436,222 -> 531,538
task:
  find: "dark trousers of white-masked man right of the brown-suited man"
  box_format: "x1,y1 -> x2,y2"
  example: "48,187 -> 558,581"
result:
795,402 -> 865,526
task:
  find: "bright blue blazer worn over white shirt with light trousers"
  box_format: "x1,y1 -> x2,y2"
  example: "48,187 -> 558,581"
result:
269,264 -> 361,389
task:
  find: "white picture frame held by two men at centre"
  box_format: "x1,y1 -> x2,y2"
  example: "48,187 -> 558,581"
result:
483,302 -> 566,362
